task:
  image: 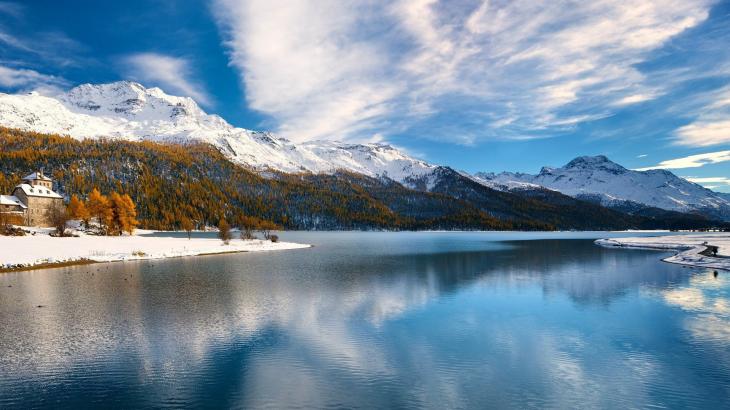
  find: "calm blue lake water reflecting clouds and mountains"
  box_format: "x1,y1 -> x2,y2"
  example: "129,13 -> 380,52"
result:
0,232 -> 730,409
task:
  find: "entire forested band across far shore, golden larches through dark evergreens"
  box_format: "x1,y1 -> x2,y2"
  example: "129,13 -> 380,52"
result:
0,128 -> 714,230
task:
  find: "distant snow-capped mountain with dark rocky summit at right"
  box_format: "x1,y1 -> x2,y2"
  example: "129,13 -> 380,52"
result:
475,155 -> 730,219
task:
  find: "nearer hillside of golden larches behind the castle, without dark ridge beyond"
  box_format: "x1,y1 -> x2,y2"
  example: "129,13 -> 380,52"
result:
0,129 -> 528,229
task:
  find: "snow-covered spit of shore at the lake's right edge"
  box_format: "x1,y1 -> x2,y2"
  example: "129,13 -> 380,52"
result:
596,233 -> 730,270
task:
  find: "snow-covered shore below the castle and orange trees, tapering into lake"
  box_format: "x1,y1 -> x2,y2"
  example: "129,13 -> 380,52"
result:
0,231 -> 310,269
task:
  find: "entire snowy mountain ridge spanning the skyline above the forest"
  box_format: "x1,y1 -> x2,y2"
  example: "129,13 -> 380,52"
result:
0,81 -> 730,220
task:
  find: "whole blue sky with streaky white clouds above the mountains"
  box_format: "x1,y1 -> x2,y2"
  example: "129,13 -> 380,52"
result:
0,0 -> 730,192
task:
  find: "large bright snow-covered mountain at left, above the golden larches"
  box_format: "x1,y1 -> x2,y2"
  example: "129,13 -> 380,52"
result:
0,81 -> 437,181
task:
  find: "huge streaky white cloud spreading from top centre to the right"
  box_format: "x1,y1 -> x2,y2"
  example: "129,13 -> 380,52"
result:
213,0 -> 712,143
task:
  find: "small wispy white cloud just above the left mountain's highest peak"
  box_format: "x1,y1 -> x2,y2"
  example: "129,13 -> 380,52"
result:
123,53 -> 212,106
